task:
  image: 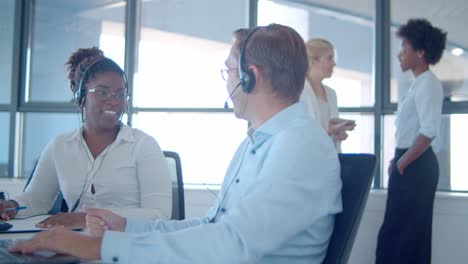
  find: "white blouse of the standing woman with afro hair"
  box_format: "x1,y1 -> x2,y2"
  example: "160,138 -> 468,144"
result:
395,70 -> 443,148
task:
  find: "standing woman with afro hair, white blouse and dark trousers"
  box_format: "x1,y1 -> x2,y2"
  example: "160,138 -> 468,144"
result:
376,19 -> 447,264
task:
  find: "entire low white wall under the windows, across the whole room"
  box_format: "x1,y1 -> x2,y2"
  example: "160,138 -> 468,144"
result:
0,179 -> 468,264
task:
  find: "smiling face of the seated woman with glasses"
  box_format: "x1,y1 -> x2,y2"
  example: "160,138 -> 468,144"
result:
83,72 -> 126,130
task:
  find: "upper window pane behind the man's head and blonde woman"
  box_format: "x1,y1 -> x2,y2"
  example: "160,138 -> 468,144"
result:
258,0 -> 375,107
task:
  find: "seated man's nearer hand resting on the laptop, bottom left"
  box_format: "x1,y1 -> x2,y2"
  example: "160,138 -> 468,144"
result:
10,226 -> 102,260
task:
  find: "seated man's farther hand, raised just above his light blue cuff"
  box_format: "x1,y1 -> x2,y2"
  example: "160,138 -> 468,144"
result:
85,208 -> 127,237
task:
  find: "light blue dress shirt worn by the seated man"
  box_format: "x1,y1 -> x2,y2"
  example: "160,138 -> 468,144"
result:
101,103 -> 341,264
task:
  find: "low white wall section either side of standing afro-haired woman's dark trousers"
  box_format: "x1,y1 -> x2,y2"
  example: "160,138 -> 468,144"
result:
349,191 -> 468,264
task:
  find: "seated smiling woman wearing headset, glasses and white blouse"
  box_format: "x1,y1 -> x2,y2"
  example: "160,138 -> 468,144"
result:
0,47 -> 172,227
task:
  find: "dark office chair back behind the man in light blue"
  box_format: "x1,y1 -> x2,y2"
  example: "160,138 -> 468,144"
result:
323,154 -> 376,264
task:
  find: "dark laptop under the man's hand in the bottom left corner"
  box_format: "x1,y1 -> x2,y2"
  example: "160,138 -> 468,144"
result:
0,239 -> 80,264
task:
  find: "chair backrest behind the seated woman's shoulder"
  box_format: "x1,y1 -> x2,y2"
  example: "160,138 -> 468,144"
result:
163,151 -> 185,220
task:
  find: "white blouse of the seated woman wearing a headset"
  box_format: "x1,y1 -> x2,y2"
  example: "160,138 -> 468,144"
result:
12,125 -> 172,219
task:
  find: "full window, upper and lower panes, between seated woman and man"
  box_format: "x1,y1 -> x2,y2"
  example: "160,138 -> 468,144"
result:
133,0 -> 248,184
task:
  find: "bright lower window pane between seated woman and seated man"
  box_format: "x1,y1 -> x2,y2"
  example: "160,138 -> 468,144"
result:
134,112 -> 247,184
